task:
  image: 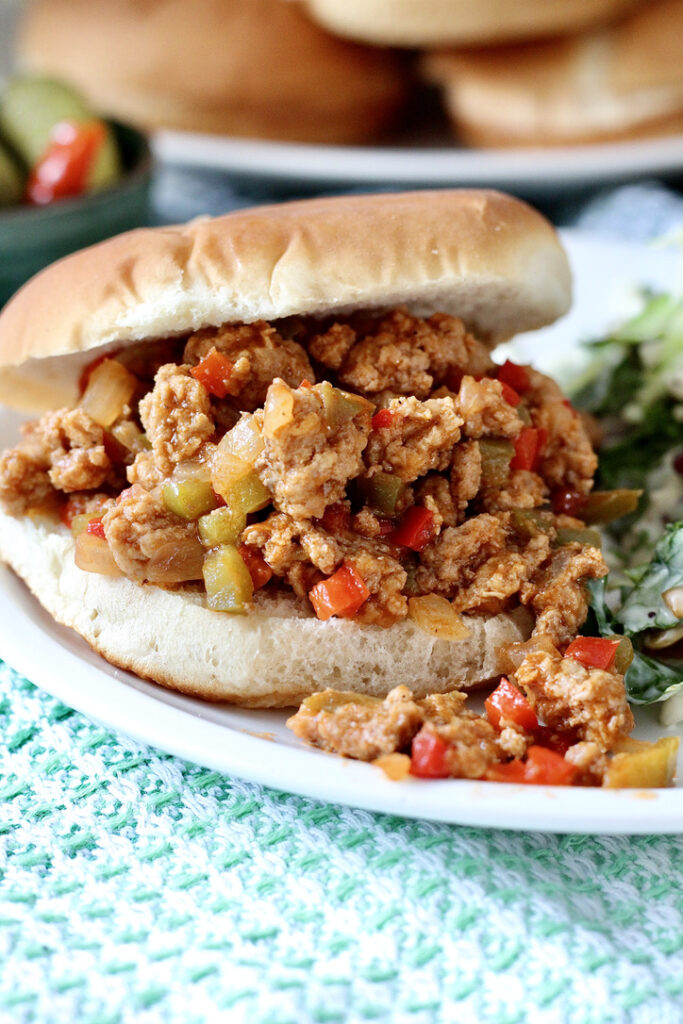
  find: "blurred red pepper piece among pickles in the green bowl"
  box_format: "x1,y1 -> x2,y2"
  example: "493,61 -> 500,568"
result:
26,121 -> 106,206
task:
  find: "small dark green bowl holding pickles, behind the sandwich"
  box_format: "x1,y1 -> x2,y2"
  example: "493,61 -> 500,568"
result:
0,123 -> 152,306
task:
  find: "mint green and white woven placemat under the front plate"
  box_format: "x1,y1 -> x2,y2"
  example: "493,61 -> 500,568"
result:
0,665 -> 683,1024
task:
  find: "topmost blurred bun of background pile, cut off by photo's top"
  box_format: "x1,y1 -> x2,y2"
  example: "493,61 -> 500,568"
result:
307,0 -> 637,47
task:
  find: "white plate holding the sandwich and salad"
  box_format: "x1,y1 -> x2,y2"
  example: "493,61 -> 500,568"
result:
0,236 -> 683,834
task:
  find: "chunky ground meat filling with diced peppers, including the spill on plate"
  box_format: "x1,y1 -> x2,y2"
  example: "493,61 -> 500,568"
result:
0,309 -> 633,783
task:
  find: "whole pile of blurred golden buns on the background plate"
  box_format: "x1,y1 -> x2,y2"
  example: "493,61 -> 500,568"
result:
13,0 -> 683,146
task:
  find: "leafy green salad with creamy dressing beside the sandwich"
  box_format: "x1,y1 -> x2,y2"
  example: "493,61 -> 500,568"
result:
572,291 -> 683,724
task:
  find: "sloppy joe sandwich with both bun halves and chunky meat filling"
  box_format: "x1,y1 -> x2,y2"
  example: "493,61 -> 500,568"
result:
0,190 -> 623,720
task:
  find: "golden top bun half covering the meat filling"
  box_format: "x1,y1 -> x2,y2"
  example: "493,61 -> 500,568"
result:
0,190 -> 570,411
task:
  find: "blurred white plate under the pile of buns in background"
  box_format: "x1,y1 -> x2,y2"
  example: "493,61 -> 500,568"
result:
153,131 -> 683,195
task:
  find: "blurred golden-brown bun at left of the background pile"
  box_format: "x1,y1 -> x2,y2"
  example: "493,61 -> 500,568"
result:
18,0 -> 408,142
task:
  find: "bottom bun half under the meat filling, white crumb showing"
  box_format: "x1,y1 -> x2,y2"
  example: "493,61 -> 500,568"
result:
0,512 -> 531,708
